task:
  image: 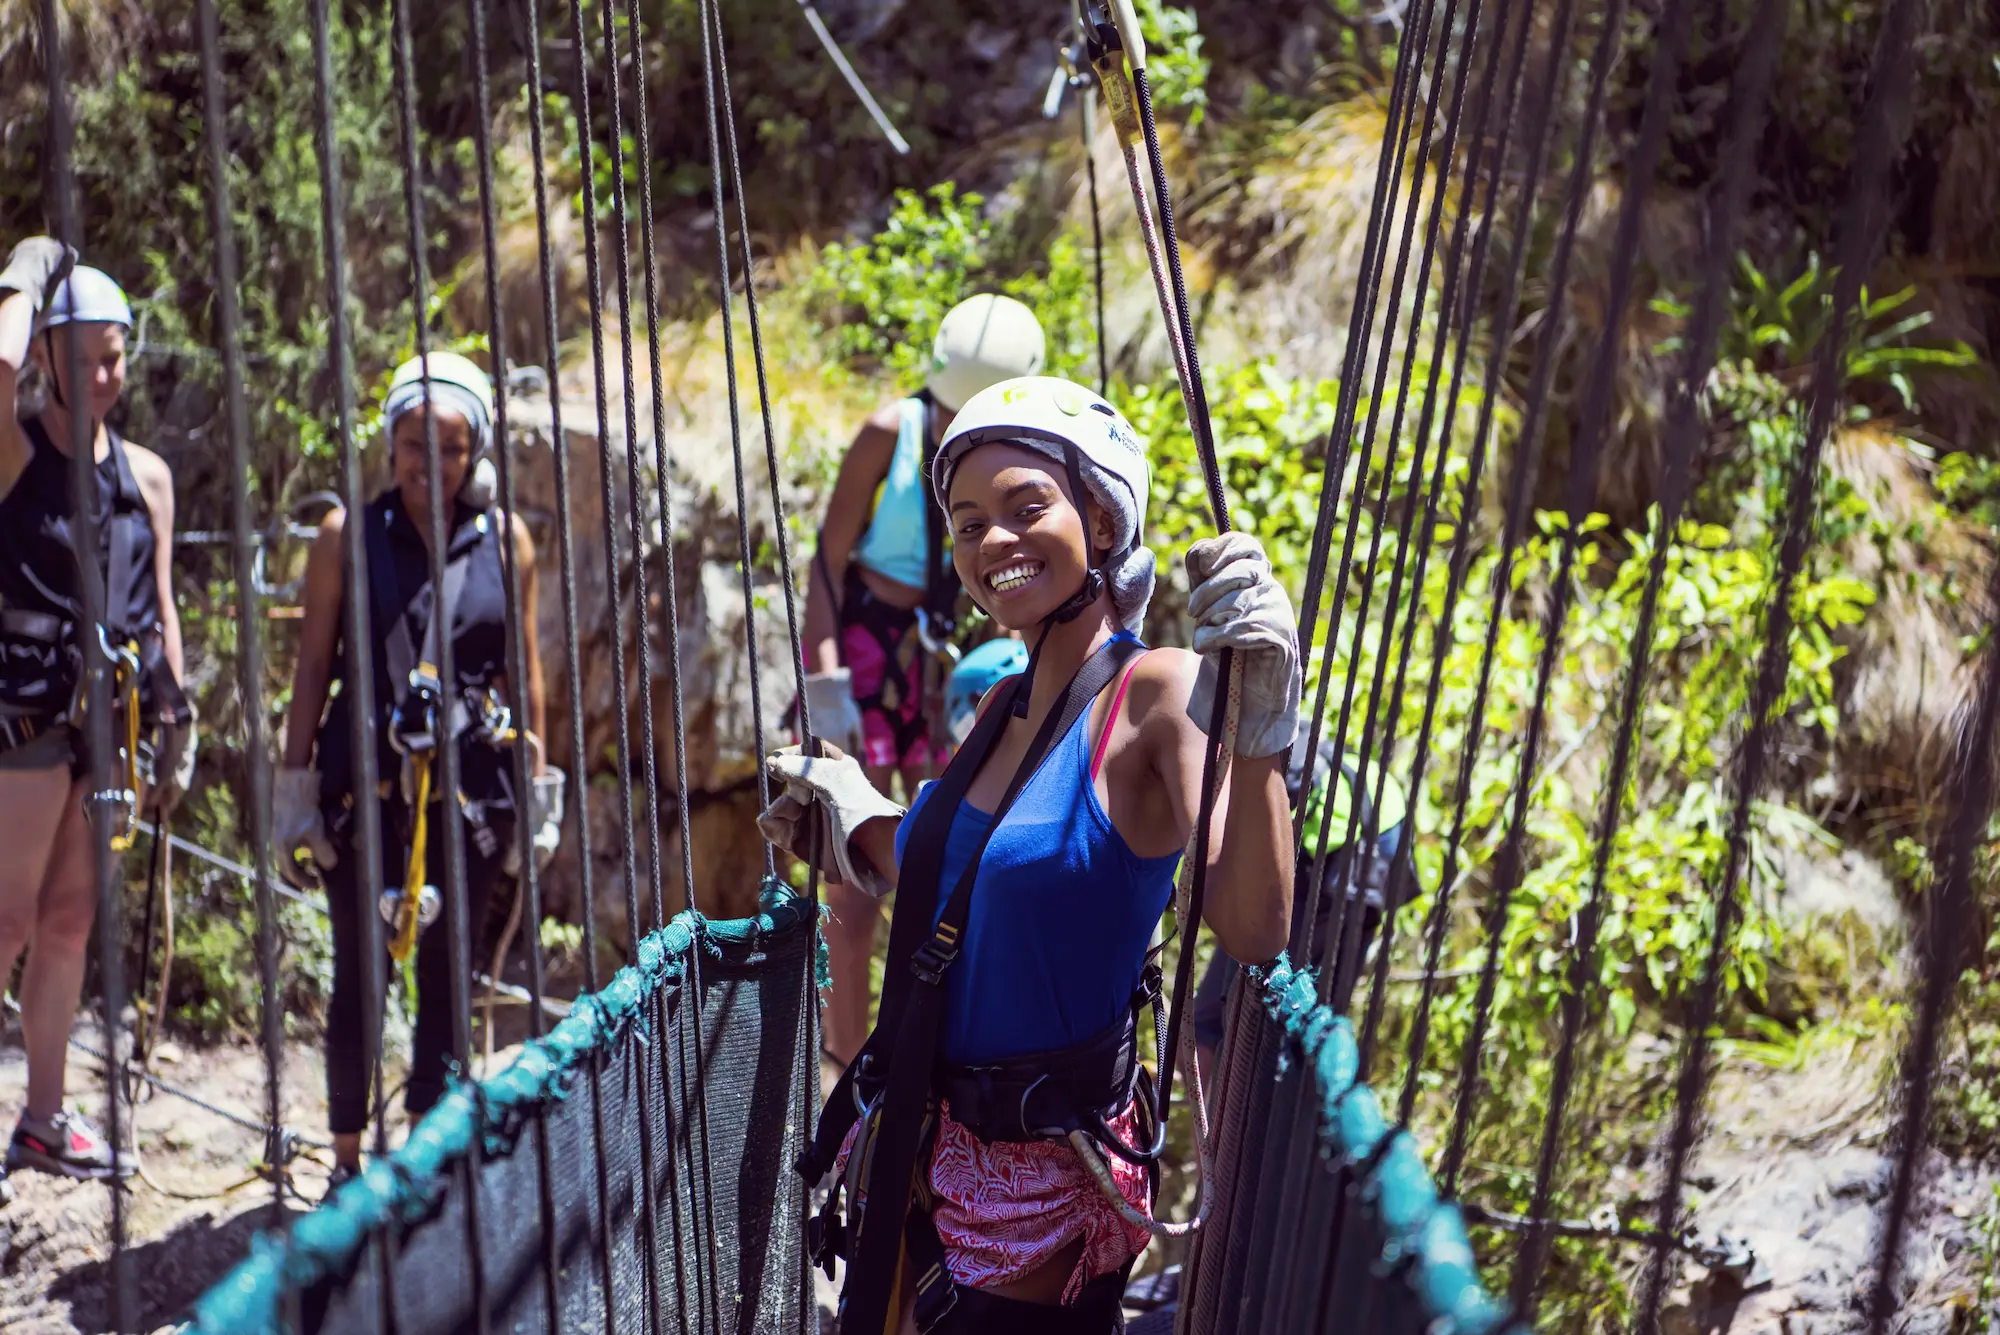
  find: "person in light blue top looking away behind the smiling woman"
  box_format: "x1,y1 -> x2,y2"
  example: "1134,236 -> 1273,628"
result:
806,296 -> 1044,1061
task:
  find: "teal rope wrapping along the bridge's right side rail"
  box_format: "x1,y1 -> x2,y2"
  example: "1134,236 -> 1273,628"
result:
1248,955 -> 1506,1335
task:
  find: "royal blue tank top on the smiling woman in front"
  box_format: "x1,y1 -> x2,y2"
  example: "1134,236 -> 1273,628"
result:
896,679 -> 1180,1063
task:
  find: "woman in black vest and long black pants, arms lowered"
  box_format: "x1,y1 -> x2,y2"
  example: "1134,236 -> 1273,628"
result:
272,354 -> 560,1185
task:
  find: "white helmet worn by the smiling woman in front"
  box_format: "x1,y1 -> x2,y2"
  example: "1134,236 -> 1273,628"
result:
930,376 -> 1156,634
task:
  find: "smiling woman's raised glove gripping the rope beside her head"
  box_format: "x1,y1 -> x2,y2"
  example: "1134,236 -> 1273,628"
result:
1188,534 -> 1304,759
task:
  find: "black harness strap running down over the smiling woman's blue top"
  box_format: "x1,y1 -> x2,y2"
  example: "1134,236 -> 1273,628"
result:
822,636 -> 1144,1335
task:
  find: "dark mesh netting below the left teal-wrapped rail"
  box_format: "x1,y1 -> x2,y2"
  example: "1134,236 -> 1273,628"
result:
300,923 -> 818,1335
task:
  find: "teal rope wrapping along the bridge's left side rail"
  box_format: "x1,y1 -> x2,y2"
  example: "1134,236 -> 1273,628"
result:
188,891 -> 818,1335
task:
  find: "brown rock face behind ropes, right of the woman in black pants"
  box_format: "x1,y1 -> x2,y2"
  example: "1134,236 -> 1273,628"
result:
508,369 -> 836,945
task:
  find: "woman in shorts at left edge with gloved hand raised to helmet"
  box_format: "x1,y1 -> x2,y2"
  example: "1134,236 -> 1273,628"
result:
0,236 -> 192,1177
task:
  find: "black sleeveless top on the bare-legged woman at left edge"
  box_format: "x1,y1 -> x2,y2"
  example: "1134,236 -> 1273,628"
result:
0,418 -> 184,721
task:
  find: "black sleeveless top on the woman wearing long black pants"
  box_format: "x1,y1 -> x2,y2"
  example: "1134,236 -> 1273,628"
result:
314,488 -> 512,805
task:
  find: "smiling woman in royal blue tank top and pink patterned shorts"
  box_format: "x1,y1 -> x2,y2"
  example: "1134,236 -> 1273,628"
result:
760,378 -> 1300,1333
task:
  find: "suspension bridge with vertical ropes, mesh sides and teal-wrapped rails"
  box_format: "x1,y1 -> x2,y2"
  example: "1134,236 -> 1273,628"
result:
11,0 -> 2000,1335
